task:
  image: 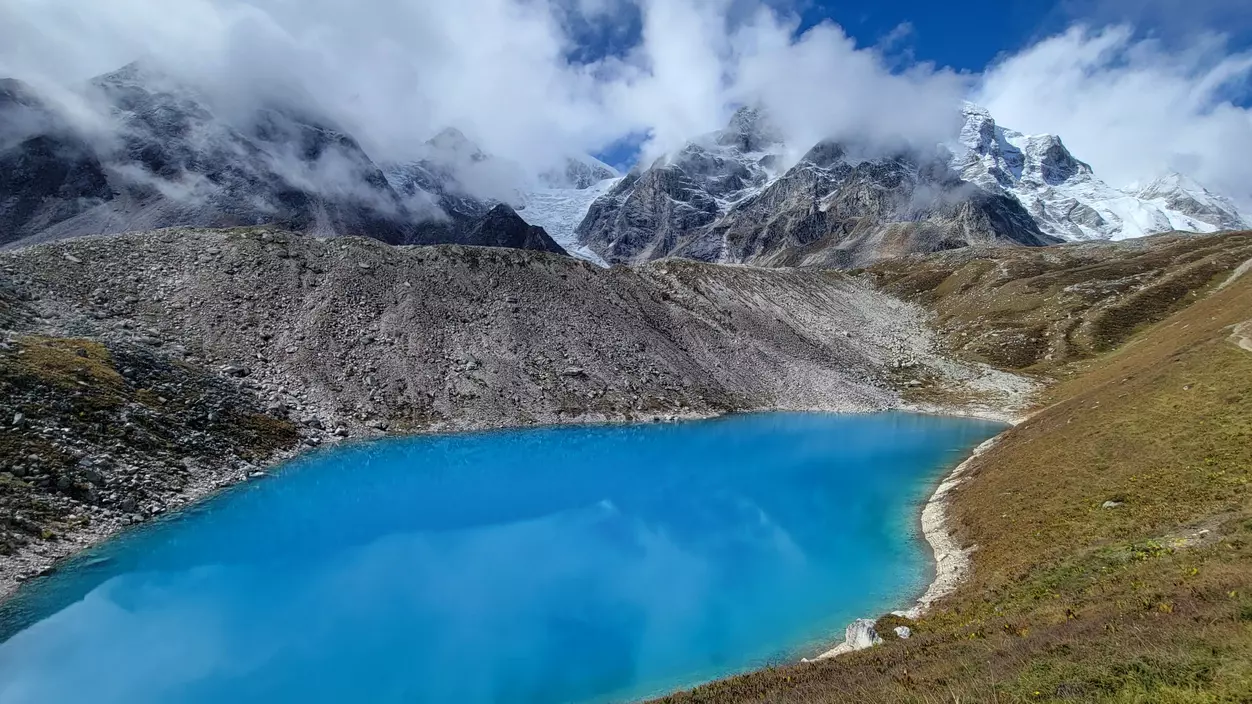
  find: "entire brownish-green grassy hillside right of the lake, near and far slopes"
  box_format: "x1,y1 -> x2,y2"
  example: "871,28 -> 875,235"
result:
667,233 -> 1252,703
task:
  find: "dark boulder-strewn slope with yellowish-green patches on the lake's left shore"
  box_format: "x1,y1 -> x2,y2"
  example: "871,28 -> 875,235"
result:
0,334 -> 299,555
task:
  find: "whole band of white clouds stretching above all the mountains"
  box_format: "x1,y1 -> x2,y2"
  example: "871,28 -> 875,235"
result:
0,0 -> 1252,202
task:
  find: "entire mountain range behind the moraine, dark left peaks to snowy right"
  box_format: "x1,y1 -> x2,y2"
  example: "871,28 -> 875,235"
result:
0,63 -> 1248,260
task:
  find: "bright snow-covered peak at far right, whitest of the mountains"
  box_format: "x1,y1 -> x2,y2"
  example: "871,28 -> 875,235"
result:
953,104 -> 1249,241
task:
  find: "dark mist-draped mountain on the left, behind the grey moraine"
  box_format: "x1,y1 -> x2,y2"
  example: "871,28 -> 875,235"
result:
0,64 -> 561,251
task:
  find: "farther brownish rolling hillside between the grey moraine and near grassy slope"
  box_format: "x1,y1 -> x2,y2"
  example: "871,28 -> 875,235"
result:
868,232 -> 1252,373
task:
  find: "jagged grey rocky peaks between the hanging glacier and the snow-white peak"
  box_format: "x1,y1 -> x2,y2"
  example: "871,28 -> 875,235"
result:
578,109 -> 1054,266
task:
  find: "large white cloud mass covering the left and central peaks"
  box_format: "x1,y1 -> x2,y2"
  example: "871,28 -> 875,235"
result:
0,0 -> 962,175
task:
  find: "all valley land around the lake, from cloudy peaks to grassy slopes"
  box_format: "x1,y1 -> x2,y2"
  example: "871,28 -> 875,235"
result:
0,51 -> 1252,703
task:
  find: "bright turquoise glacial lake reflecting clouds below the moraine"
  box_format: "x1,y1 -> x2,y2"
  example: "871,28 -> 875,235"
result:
0,413 -> 1000,704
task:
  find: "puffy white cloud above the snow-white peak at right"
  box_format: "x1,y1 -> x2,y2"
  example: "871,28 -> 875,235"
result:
974,26 -> 1252,207
